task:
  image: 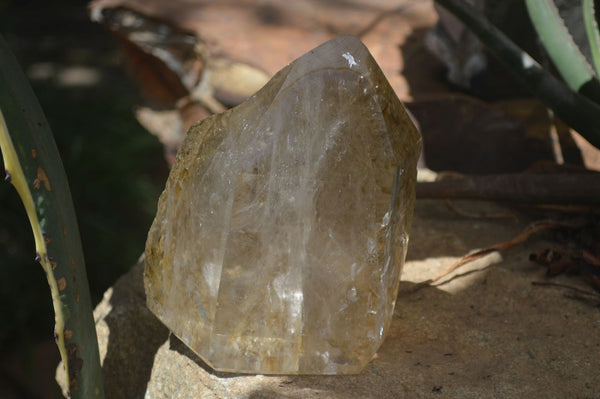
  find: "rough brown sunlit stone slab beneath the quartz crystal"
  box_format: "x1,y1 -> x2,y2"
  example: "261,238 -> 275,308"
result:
58,200 -> 600,399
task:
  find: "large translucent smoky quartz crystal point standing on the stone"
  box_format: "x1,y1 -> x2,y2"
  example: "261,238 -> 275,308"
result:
144,36 -> 421,374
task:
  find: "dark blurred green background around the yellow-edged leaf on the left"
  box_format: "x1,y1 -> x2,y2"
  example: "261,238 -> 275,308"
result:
0,0 -> 168,399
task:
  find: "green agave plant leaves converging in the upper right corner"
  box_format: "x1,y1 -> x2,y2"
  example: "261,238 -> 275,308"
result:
436,0 -> 600,148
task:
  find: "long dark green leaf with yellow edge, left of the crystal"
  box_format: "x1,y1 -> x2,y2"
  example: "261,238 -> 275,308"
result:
0,36 -> 104,398
